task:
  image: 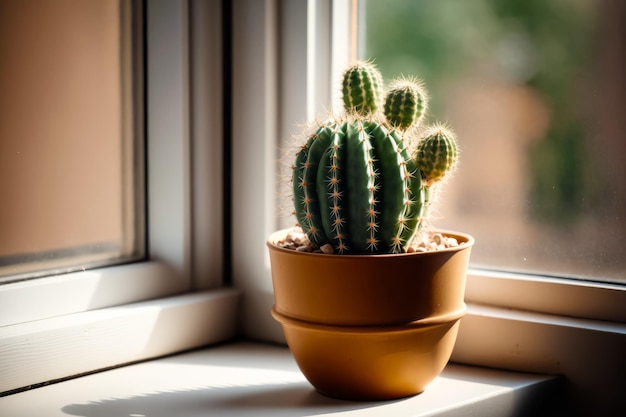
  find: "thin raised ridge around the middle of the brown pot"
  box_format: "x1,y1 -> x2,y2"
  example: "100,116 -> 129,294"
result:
271,303 -> 467,335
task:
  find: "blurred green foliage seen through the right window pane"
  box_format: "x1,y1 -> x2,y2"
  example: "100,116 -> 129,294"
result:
359,0 -> 597,224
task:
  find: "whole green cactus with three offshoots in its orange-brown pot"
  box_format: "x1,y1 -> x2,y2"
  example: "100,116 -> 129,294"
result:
267,62 -> 474,400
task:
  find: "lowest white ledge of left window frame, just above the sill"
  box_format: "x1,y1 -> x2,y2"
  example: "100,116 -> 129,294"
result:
0,288 -> 240,395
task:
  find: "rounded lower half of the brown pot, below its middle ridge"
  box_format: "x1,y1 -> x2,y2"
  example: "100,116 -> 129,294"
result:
272,309 -> 463,400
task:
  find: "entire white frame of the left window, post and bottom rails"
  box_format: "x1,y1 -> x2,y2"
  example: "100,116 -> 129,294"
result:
0,0 -> 238,392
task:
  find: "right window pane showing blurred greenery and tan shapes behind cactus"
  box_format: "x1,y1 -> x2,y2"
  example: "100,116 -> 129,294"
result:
359,0 -> 626,282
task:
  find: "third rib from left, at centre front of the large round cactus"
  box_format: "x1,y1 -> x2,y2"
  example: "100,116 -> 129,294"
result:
345,121 -> 379,252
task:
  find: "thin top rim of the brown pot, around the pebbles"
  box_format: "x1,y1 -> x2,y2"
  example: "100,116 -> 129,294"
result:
265,227 -> 475,259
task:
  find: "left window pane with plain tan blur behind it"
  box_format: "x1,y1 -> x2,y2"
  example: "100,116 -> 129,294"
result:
0,0 -> 143,281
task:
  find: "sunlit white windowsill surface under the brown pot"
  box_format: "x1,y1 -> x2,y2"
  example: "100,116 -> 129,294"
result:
0,342 -> 561,417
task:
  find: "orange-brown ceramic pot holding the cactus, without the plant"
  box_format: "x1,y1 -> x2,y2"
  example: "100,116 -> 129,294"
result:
267,230 -> 474,400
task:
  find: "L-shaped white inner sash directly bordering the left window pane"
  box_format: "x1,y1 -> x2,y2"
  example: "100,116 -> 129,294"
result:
0,0 -> 190,325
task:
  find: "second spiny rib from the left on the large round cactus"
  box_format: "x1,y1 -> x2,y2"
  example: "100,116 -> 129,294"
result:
317,129 -> 349,253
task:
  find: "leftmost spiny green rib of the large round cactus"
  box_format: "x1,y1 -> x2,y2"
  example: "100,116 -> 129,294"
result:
293,126 -> 332,246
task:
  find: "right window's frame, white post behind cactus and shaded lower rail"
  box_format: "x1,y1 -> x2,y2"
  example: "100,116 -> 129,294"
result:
233,0 -> 626,411
